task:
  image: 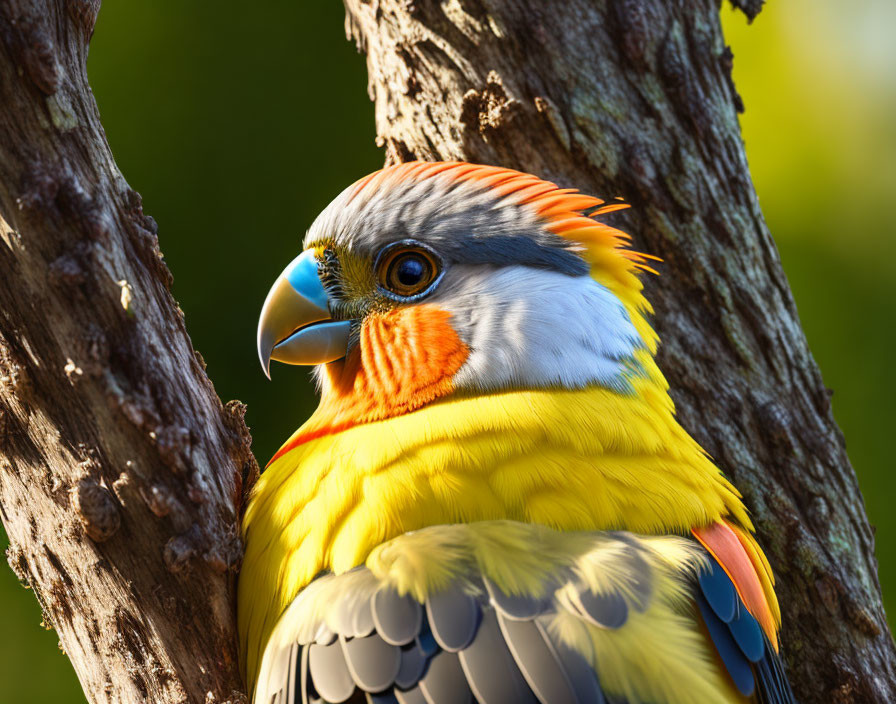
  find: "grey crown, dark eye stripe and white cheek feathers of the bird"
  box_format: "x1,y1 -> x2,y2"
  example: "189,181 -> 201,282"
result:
305,168 -> 644,392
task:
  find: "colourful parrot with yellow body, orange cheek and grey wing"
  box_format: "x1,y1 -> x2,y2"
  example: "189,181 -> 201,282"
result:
237,161 -> 794,704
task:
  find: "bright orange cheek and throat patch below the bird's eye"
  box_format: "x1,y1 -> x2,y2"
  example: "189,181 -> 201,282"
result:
271,304 -> 469,462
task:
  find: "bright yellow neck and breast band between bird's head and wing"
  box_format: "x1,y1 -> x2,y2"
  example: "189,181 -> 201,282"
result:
245,379 -> 749,620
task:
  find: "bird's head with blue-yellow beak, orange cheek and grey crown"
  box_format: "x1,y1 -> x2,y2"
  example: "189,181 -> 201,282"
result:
258,162 -> 661,452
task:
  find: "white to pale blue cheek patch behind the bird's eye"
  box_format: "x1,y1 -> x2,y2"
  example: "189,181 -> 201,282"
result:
426,266 -> 644,391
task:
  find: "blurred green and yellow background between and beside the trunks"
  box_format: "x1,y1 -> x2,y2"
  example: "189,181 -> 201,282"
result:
0,0 -> 896,704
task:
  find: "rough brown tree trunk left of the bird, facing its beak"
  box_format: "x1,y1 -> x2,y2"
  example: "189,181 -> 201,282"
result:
0,0 -> 257,704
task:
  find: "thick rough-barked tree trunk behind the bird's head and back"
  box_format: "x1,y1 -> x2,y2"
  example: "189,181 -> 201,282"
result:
345,0 -> 896,703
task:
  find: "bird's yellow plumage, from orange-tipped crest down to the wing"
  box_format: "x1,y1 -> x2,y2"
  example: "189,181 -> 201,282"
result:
238,164 -> 780,704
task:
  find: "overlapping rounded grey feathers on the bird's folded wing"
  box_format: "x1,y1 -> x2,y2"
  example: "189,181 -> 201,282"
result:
255,578 -> 625,704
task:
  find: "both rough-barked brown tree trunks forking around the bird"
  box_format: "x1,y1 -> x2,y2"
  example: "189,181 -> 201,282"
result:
0,0 -> 896,704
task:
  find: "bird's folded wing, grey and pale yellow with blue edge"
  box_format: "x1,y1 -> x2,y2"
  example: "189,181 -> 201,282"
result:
248,521 -> 786,704
